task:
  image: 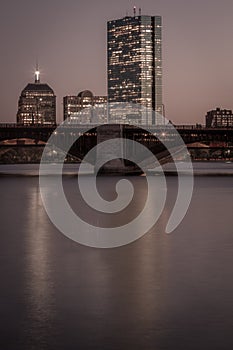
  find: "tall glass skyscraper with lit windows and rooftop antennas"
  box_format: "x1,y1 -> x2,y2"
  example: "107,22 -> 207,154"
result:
108,8 -> 163,124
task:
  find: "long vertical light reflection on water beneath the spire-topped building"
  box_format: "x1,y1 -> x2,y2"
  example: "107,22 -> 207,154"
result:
24,187 -> 55,340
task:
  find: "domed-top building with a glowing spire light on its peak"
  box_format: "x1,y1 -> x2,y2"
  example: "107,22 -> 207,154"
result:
17,69 -> 56,125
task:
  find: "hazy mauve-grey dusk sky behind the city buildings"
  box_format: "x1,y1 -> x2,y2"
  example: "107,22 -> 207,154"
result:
0,0 -> 233,124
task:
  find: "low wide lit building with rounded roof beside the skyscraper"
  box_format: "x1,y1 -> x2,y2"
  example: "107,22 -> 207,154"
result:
63,90 -> 107,124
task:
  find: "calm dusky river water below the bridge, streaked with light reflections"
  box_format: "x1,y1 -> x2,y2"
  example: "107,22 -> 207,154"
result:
0,163 -> 233,350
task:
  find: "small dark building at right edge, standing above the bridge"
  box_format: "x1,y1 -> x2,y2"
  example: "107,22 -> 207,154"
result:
205,108 -> 233,128
